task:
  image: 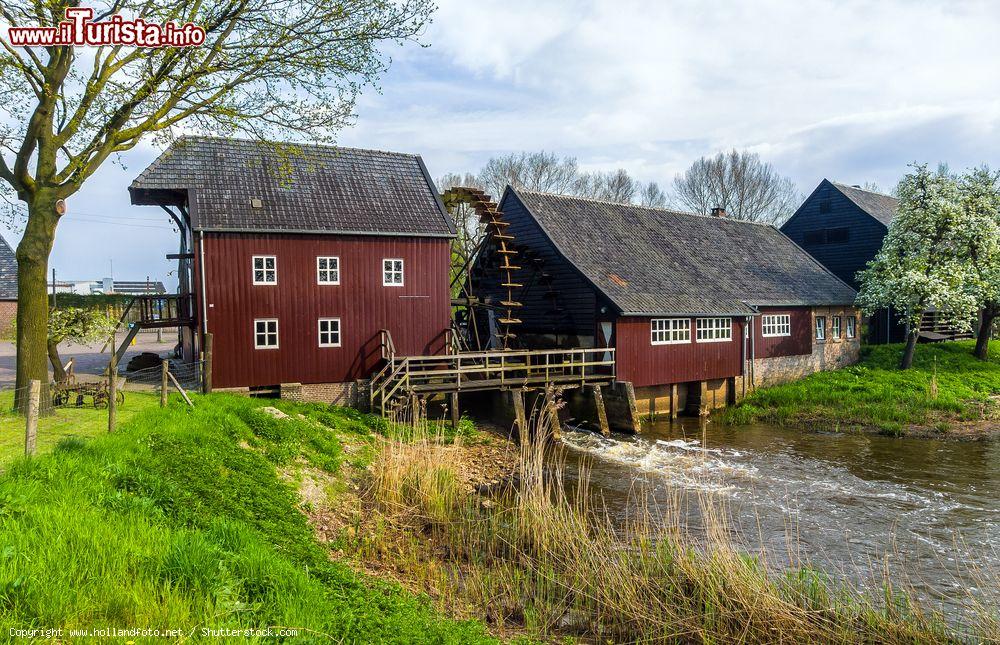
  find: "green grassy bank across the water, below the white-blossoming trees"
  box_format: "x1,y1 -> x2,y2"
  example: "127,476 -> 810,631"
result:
717,341 -> 1000,435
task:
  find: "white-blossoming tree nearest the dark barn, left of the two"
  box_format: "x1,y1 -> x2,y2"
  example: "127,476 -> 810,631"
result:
858,165 -> 976,369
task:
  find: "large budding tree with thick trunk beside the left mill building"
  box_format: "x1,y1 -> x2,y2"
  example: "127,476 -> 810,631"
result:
0,0 -> 434,407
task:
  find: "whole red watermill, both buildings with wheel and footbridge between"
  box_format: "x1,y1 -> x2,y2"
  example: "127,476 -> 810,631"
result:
123,137 -> 858,429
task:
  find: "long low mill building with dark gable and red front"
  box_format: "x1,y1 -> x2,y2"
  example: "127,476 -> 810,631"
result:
473,188 -> 860,414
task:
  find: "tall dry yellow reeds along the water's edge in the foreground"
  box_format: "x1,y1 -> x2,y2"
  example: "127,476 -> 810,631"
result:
351,410 -> 1000,643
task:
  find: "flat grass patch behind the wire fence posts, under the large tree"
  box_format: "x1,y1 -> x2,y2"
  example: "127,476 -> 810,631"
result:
0,390 -> 160,462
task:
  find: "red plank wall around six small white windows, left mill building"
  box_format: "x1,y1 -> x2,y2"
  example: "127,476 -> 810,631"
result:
196,233 -> 451,387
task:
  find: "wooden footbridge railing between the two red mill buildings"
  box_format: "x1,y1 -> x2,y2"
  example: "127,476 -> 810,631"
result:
370,348 -> 615,414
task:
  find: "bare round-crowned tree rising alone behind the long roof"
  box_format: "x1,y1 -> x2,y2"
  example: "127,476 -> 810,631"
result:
674,150 -> 802,225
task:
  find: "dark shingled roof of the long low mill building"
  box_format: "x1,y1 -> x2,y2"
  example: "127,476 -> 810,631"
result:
508,188 -> 856,315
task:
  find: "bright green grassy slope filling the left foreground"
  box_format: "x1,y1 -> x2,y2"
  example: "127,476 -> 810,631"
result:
0,395 -> 488,642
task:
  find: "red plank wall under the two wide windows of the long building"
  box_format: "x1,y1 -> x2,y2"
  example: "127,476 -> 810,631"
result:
615,316 -> 744,387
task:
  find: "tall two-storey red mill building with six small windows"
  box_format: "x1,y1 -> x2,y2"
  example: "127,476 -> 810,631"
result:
129,137 -> 455,402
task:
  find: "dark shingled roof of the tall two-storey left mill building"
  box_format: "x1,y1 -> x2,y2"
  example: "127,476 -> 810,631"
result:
129,137 -> 455,236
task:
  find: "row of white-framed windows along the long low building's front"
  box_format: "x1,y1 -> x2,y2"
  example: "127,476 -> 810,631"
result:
650,314 -> 858,345
